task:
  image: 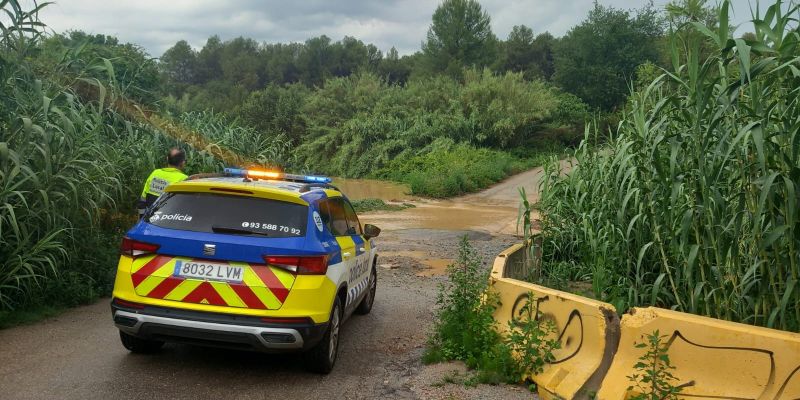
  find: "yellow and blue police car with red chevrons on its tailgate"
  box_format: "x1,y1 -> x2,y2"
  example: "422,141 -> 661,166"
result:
111,169 -> 380,373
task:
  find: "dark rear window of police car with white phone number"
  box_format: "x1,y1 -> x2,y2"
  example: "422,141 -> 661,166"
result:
145,193 -> 308,238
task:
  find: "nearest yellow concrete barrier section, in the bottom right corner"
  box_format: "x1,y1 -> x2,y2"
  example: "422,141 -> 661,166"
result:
597,307 -> 800,400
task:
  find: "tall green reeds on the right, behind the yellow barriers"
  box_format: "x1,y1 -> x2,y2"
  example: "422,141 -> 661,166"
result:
538,1 -> 800,331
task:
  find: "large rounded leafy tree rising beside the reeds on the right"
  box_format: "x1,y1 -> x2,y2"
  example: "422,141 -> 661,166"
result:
553,3 -> 663,111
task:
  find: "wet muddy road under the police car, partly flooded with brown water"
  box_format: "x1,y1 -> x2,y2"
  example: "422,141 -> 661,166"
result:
0,164 -> 552,399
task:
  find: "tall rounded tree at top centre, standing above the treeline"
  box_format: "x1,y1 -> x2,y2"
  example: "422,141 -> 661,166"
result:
422,0 -> 497,76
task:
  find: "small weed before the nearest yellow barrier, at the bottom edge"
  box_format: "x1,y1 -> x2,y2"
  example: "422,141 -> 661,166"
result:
627,331 -> 681,400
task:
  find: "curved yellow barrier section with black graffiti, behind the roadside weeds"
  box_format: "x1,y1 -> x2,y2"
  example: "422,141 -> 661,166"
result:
490,244 -> 619,399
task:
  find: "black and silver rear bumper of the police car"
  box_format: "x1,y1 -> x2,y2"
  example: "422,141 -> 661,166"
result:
111,301 -> 328,352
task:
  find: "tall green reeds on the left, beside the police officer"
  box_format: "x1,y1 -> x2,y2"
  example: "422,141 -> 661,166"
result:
0,0 -> 227,315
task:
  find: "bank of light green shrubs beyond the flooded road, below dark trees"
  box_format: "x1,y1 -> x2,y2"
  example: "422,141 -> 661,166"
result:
297,70 -> 583,197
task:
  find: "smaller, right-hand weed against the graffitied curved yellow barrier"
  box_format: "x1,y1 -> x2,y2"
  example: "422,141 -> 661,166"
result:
505,292 -> 561,381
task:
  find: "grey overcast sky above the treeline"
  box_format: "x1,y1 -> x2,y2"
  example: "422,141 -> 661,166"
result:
40,0 -> 770,57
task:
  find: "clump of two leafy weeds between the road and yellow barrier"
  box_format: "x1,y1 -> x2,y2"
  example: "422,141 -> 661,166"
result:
423,237 -> 560,385
